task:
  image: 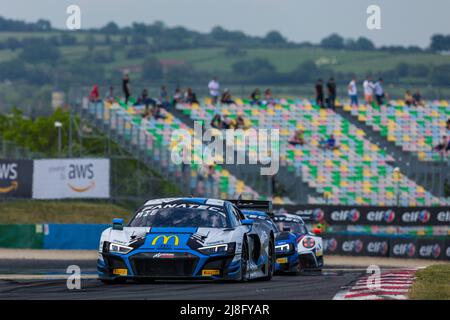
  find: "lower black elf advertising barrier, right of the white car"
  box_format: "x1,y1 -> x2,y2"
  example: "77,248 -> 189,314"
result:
323,233 -> 450,260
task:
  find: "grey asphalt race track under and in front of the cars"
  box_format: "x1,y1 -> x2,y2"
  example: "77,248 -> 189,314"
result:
0,260 -> 364,300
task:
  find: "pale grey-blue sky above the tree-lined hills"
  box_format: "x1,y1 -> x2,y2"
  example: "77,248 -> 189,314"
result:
0,0 -> 450,47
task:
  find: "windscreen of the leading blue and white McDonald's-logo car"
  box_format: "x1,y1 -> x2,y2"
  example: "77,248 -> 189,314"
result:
129,206 -> 228,228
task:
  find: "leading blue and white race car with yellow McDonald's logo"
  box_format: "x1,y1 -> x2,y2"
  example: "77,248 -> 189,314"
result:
97,198 -> 275,283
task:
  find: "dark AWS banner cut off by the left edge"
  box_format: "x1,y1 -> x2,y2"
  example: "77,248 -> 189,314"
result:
0,159 -> 33,198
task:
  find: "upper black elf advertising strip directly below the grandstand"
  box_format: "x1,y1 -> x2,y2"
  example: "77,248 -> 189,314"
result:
274,205 -> 450,226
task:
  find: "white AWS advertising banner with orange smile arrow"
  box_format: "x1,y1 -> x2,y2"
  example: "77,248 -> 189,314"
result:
33,159 -> 110,199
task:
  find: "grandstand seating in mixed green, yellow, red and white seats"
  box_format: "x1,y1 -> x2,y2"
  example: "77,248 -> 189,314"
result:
85,95 -> 449,206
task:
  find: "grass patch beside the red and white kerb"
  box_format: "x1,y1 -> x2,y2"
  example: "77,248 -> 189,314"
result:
410,264 -> 450,300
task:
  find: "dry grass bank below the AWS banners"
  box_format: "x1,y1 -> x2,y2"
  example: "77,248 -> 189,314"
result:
0,200 -> 132,224
